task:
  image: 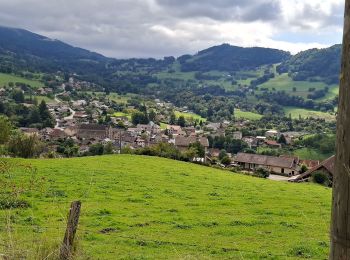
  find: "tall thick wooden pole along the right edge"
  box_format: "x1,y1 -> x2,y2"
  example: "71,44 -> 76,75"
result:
329,0 -> 350,260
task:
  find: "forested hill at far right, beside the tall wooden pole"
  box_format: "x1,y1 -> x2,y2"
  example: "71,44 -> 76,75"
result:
277,44 -> 341,84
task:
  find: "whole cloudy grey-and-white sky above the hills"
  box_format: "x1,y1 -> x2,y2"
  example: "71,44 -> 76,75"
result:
0,0 -> 345,58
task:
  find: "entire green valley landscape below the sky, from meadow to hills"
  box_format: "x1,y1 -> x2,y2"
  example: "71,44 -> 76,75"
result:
0,26 -> 341,259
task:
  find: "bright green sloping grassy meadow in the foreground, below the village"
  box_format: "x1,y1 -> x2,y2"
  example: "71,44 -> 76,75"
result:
0,155 -> 331,259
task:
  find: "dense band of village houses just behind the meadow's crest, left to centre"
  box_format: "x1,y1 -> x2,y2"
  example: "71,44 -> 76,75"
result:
21,119 -> 209,156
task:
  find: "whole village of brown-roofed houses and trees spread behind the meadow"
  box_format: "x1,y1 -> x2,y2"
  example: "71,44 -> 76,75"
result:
7,78 -> 334,186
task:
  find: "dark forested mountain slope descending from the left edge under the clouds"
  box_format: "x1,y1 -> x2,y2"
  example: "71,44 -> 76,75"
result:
0,26 -> 110,72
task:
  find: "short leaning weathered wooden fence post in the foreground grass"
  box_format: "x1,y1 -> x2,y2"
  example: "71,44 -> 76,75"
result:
60,201 -> 81,260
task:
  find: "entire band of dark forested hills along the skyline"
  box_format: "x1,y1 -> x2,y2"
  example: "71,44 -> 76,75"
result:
0,26 -> 341,89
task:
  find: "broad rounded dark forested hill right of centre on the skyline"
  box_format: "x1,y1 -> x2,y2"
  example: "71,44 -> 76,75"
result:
178,44 -> 291,72
